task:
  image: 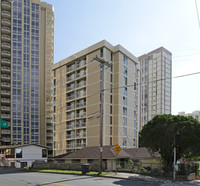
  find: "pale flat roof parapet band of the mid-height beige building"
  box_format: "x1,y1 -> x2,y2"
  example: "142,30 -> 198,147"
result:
53,40 -> 138,69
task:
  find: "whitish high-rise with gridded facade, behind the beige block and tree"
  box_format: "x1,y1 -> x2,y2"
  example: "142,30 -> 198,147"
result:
139,47 -> 172,130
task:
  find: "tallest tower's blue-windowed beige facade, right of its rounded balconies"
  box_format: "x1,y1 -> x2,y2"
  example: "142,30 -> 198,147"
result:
0,0 -> 54,150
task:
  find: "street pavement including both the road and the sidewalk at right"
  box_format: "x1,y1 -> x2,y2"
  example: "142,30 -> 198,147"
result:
0,169 -> 200,186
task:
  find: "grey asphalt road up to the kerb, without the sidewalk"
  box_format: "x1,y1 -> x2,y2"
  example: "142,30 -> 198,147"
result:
0,169 -> 198,186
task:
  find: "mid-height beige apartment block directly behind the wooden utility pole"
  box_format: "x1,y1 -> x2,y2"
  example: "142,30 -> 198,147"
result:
54,40 -> 140,155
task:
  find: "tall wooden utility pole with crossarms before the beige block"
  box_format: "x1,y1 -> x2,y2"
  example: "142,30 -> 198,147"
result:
92,56 -> 111,174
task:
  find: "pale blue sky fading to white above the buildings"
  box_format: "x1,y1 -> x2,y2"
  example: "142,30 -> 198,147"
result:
44,0 -> 200,114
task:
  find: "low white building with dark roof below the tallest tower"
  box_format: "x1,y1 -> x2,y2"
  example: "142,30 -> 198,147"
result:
0,144 -> 48,168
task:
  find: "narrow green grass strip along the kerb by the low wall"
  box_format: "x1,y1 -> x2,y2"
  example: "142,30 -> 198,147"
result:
28,169 -> 109,176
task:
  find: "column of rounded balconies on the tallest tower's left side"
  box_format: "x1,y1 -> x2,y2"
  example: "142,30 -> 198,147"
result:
0,0 -> 12,145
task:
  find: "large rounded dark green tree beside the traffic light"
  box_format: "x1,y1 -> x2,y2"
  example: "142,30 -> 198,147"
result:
140,114 -> 200,166
